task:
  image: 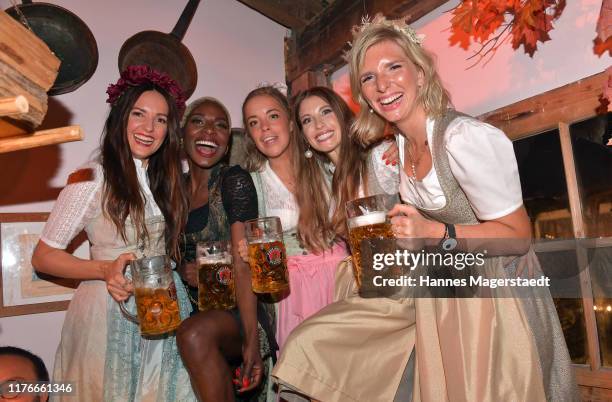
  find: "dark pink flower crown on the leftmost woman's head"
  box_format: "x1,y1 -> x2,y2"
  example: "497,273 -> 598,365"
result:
106,65 -> 186,113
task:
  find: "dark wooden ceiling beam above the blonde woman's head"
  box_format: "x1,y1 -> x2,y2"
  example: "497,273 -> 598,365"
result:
286,0 -> 448,83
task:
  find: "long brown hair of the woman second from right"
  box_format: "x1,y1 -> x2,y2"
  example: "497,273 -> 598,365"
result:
292,87 -> 367,251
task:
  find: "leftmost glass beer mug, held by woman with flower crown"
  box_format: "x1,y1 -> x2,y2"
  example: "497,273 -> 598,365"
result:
119,255 -> 181,336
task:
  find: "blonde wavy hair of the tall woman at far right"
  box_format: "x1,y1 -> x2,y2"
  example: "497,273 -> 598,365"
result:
347,14 -> 451,146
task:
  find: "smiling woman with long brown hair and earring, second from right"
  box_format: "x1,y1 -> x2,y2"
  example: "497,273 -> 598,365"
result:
292,87 -> 399,249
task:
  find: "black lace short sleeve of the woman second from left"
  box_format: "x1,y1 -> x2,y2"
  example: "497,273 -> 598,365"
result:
221,165 -> 257,225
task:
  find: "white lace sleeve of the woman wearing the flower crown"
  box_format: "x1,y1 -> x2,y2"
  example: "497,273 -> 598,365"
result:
40,164 -> 102,250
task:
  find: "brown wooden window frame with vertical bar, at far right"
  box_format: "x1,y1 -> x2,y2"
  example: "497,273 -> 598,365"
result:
478,71 -> 612,389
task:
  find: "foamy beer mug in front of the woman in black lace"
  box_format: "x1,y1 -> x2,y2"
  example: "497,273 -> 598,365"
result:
196,240 -> 236,311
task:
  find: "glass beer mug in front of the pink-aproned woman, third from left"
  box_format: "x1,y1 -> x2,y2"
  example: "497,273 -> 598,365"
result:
245,216 -> 289,293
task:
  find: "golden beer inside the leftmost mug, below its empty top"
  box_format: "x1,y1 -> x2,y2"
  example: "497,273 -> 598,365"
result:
134,282 -> 181,335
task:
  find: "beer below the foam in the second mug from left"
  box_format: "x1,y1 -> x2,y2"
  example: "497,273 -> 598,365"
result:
198,262 -> 236,311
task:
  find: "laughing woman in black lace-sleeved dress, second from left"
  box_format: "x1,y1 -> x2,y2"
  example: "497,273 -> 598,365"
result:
177,98 -> 266,402
